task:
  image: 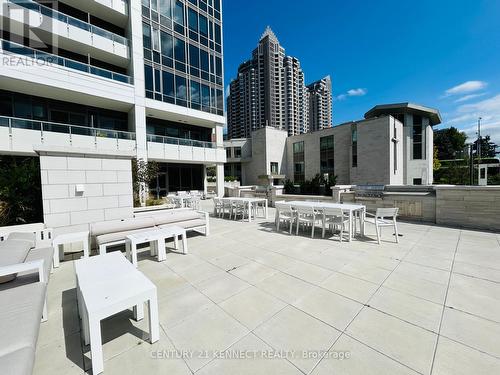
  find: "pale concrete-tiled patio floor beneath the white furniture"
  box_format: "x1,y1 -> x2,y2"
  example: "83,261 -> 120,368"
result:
34,202 -> 500,375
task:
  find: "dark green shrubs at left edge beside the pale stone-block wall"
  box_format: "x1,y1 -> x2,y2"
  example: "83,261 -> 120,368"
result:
0,156 -> 43,226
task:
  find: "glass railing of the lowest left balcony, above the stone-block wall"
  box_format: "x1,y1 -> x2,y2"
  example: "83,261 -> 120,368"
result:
0,116 -> 135,141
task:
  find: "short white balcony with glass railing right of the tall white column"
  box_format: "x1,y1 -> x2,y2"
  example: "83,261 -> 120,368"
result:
147,134 -> 226,163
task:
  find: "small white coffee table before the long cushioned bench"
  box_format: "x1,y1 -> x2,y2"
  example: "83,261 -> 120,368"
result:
125,225 -> 187,267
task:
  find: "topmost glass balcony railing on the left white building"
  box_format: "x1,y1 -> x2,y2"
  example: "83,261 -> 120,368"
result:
7,0 -> 129,46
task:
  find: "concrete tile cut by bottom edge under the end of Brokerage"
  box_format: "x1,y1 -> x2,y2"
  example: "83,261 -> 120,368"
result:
312,335 -> 418,375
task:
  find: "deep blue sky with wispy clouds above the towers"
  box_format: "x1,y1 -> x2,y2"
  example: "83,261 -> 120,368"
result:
223,0 -> 500,144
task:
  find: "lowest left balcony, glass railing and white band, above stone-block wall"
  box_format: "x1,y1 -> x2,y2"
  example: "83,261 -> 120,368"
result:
0,116 -> 136,154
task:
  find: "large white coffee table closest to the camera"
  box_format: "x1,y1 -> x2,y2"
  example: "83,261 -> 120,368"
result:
75,251 -> 160,374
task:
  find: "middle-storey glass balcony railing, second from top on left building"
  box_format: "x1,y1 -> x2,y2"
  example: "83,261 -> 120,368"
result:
1,40 -> 133,85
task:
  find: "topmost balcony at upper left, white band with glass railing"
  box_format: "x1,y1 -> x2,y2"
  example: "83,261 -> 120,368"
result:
0,0 -> 129,66
